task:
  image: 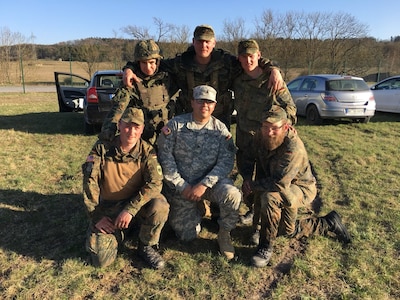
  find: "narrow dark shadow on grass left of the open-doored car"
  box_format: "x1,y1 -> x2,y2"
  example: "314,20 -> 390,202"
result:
0,112 -> 88,135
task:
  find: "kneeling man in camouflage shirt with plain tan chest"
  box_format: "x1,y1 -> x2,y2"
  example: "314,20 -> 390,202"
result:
82,107 -> 169,269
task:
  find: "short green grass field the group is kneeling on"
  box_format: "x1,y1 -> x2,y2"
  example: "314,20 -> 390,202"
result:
0,93 -> 400,299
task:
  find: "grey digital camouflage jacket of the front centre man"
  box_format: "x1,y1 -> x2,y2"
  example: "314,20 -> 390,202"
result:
157,113 -> 236,192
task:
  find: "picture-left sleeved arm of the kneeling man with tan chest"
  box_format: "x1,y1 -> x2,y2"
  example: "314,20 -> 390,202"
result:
82,141 -> 103,219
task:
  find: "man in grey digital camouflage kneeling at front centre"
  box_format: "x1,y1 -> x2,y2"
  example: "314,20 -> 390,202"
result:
157,85 -> 242,260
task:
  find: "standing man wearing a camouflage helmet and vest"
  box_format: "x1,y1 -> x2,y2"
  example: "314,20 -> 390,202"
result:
99,40 -> 178,146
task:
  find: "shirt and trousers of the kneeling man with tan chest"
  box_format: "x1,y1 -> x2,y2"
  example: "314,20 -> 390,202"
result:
82,136 -> 169,266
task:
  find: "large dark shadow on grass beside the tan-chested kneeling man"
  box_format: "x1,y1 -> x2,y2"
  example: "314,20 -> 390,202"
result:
0,190 -> 87,261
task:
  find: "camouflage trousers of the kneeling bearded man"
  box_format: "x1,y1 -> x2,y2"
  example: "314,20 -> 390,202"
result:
253,185 -> 329,244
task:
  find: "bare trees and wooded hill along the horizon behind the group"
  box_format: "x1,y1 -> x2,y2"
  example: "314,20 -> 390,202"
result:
0,10 -> 400,82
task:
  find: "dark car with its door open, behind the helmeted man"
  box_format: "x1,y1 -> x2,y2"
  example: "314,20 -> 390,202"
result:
54,70 -> 123,134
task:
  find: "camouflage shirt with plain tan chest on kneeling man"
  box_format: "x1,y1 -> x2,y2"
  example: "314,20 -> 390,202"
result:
82,136 -> 163,221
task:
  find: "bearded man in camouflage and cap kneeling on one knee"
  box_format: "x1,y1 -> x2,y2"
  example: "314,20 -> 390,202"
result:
242,105 -> 350,267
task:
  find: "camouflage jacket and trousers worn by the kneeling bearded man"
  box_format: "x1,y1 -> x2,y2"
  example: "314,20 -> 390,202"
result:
243,126 -> 338,245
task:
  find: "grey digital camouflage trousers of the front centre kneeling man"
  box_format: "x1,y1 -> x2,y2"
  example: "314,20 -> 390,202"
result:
165,178 -> 242,241
